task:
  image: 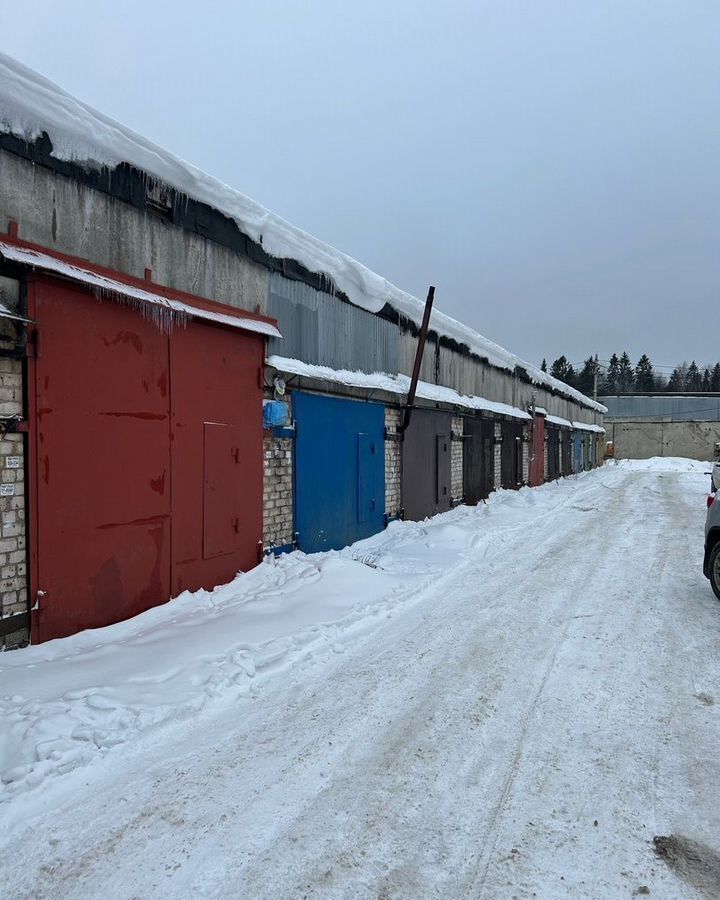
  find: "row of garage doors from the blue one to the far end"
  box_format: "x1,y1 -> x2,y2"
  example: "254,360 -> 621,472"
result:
282,391 -> 598,552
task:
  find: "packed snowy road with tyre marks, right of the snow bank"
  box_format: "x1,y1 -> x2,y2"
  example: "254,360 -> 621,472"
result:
0,463 -> 720,900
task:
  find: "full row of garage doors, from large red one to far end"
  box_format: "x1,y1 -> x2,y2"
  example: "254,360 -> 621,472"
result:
0,237 -> 597,640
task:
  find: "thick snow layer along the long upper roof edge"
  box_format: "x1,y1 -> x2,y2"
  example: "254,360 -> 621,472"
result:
0,53 -> 605,412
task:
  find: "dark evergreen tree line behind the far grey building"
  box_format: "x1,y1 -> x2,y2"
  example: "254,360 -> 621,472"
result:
541,353 -> 720,396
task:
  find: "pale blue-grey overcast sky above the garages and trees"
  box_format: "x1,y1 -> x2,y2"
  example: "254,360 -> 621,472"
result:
0,0 -> 720,365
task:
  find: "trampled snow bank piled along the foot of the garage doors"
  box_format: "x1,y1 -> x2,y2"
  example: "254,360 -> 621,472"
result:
0,471 -> 620,802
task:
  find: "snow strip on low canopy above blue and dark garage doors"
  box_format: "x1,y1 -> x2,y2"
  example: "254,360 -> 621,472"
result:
267,356 -> 530,419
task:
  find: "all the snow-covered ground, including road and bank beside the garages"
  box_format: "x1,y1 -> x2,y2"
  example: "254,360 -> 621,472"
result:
0,460 -> 720,900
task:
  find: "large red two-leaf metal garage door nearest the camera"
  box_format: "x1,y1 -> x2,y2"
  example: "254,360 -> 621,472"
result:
29,280 -> 264,641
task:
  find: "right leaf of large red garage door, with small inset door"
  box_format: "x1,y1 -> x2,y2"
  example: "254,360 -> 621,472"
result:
170,323 -> 264,595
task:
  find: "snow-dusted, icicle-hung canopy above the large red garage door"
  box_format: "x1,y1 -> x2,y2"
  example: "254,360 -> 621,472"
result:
0,239 -> 282,337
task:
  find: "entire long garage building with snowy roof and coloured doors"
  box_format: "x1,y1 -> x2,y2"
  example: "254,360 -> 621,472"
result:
0,61 -> 605,646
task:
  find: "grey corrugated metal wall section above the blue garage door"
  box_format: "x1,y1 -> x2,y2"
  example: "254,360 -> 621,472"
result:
268,273 -> 398,374
